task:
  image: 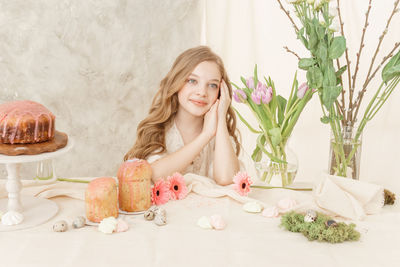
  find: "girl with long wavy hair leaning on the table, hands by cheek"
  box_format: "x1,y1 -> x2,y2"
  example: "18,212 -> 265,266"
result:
124,46 -> 240,185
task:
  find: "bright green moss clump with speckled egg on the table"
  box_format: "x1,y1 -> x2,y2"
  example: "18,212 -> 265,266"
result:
281,211 -> 360,243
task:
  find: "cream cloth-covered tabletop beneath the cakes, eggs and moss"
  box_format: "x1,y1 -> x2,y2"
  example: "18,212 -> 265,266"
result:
0,179 -> 400,267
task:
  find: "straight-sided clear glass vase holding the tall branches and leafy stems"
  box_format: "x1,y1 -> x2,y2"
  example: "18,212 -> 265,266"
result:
328,126 -> 362,180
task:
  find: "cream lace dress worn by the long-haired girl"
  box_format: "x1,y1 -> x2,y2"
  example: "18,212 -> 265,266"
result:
147,123 -> 215,178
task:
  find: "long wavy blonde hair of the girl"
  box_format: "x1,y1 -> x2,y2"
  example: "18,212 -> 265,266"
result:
124,46 -> 240,160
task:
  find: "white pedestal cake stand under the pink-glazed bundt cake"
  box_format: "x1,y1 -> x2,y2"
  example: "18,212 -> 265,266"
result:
0,138 -> 74,232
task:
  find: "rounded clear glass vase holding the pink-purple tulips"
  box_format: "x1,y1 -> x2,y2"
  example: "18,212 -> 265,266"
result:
254,142 -> 298,187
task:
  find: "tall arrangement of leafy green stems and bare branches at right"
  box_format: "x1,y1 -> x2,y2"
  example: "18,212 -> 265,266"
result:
277,0 -> 400,179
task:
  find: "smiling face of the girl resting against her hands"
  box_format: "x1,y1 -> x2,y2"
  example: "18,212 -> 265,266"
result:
178,61 -> 221,116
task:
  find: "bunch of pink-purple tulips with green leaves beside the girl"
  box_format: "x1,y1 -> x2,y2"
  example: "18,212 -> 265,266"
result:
232,65 -> 314,187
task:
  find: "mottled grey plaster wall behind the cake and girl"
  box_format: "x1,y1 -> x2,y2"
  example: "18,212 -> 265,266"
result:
0,0 -> 202,178
